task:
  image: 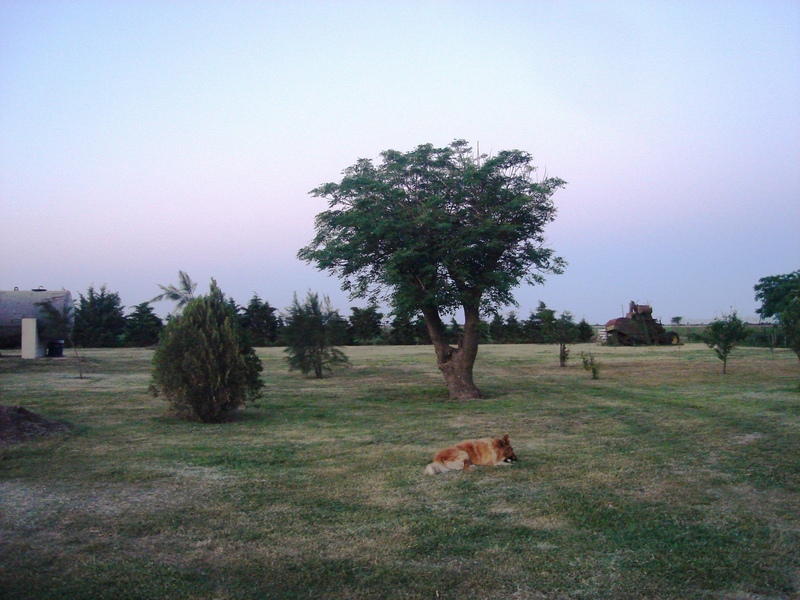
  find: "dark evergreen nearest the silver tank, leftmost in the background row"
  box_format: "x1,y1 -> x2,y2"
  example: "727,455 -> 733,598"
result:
72,285 -> 125,348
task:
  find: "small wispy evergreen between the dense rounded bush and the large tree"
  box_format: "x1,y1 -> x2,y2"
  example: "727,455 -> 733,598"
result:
283,292 -> 349,379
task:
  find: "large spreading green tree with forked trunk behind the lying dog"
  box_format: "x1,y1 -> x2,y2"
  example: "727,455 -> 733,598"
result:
298,140 -> 565,398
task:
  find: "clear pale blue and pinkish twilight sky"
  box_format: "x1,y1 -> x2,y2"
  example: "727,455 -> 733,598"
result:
0,0 -> 800,323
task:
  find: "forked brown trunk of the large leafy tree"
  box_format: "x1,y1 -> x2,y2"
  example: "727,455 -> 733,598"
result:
422,307 -> 483,400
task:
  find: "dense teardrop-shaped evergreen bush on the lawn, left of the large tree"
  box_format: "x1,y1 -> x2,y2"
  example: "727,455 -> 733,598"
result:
152,279 -> 263,423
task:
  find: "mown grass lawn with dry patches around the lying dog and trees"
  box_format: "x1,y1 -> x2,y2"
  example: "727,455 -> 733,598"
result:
0,344 -> 800,600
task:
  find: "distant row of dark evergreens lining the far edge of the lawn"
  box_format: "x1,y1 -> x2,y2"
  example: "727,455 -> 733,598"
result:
62,286 -> 594,348
